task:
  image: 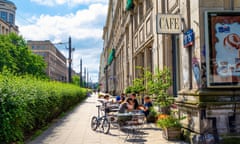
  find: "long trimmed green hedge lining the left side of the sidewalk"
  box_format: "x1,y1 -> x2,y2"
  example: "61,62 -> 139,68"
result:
0,74 -> 87,144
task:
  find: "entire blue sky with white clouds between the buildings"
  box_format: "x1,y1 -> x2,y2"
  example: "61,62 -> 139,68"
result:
10,0 -> 108,82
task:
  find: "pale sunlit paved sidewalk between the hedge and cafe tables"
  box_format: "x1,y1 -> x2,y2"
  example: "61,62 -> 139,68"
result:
26,94 -> 188,144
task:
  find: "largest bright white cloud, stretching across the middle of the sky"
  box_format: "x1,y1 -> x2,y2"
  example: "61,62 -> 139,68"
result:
19,4 -> 107,41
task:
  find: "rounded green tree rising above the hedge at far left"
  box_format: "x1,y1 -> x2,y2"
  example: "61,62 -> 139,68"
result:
0,33 -> 46,77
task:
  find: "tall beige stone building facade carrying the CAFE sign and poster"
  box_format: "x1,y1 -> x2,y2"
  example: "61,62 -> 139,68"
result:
99,0 -> 240,142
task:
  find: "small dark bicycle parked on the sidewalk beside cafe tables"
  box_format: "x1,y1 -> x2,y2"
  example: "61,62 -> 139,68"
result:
91,105 -> 110,134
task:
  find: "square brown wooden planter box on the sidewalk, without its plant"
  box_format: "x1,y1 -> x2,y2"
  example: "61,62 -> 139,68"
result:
162,127 -> 181,140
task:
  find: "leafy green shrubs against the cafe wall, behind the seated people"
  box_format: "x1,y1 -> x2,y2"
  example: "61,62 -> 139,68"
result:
125,67 -> 173,107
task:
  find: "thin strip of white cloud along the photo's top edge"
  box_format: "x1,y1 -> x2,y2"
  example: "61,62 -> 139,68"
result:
31,0 -> 107,6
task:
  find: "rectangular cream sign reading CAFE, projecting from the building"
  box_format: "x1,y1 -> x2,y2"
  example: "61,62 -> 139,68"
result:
157,14 -> 182,34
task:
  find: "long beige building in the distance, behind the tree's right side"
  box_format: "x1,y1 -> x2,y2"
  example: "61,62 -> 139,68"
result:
27,40 -> 68,82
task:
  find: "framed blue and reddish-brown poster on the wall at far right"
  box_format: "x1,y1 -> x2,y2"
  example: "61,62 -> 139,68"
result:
205,11 -> 240,88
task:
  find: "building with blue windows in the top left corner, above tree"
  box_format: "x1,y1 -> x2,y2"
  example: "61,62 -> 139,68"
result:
0,0 -> 18,34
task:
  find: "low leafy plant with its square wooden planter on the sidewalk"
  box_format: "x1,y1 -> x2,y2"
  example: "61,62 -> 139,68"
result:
157,114 -> 182,140
